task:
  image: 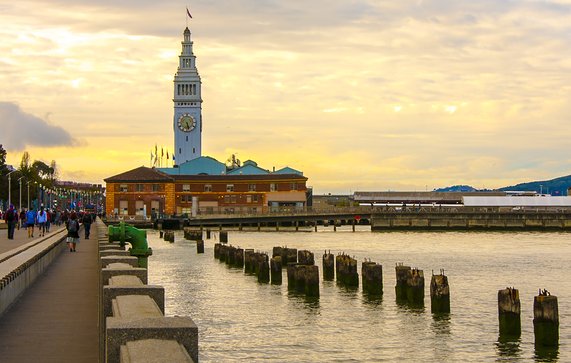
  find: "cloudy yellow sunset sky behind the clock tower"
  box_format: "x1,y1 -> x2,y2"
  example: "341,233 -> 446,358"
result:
0,0 -> 571,194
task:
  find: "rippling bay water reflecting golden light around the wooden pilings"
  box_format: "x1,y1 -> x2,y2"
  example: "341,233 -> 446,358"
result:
148,227 -> 571,362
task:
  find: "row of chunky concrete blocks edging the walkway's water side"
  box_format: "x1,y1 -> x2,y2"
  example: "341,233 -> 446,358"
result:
99,219 -> 201,363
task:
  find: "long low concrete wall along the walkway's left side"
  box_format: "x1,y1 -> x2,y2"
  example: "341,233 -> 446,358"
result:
0,229 -> 66,316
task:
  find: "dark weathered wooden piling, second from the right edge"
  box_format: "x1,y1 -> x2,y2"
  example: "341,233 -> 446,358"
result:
498,287 -> 521,337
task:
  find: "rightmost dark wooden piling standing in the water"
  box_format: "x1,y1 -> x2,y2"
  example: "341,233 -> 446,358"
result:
533,290 -> 559,347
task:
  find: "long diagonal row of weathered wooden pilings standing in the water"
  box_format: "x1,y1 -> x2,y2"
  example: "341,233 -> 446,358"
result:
185,234 -> 559,346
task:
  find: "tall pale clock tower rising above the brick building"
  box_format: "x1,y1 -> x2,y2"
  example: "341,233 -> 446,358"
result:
173,27 -> 202,165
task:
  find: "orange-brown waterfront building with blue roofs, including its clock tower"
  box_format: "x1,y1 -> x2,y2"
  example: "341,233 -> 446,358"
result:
105,28 -> 311,217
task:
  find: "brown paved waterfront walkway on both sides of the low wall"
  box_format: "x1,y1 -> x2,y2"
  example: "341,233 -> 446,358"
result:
0,225 -> 99,363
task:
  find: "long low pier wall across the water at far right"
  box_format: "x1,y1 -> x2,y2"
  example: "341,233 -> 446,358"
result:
371,212 -> 571,231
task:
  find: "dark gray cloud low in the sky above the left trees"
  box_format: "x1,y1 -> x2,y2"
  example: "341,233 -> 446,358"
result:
0,102 -> 78,151
